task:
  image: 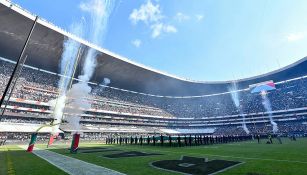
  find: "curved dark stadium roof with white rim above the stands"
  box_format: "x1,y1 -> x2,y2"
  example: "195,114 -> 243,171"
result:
0,0 -> 307,96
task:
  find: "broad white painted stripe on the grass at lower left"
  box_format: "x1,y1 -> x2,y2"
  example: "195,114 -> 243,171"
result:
19,146 -> 124,175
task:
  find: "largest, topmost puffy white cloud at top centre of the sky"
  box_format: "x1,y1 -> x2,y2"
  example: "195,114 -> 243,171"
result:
129,0 -> 163,24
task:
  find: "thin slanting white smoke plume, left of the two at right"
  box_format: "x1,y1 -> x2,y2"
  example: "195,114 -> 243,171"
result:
228,82 -> 249,134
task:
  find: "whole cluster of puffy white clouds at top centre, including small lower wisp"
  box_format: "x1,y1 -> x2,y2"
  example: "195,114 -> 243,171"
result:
129,0 -> 177,38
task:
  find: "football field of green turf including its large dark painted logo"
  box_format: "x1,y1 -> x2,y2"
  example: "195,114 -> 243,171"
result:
0,138 -> 307,175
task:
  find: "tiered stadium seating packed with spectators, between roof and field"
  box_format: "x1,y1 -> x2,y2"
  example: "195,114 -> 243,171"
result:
0,59 -> 307,138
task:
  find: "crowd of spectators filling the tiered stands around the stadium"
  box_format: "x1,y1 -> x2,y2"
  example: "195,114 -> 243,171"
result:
0,60 -> 307,134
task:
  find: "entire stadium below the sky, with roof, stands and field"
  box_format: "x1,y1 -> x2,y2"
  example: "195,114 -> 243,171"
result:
0,0 -> 307,175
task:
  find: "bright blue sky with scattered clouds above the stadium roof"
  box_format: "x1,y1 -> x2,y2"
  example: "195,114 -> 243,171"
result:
12,0 -> 307,81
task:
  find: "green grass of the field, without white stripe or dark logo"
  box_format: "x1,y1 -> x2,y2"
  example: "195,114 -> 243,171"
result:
0,138 -> 307,175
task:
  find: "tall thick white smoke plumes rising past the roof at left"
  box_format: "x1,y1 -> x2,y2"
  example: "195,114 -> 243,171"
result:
53,0 -> 114,132
